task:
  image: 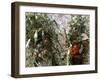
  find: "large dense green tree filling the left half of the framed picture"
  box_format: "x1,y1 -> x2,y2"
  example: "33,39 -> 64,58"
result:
26,13 -> 61,66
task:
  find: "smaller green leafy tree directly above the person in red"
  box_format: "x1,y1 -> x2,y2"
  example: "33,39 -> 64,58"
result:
68,15 -> 89,43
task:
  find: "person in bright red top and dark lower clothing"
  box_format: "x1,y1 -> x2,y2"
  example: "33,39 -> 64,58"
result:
71,42 -> 82,65
